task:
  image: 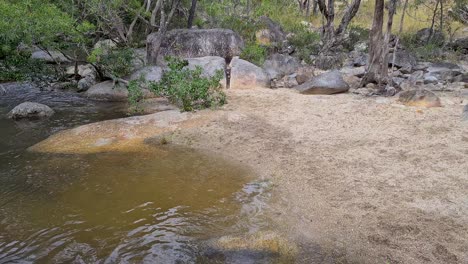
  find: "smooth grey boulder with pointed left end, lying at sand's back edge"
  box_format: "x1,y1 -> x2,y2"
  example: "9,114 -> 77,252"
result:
294,71 -> 349,94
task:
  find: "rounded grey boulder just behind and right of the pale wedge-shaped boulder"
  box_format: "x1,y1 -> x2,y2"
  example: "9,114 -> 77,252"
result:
263,53 -> 300,79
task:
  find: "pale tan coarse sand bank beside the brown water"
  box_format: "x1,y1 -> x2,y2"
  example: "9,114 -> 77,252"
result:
32,89 -> 468,263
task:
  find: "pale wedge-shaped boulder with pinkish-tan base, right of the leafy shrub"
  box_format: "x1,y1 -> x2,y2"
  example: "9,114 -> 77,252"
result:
230,57 -> 270,89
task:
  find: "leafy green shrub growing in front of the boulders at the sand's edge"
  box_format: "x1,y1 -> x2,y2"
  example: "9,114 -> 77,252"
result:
149,57 -> 226,111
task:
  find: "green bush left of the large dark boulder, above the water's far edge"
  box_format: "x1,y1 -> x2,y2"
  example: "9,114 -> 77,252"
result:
88,48 -> 135,78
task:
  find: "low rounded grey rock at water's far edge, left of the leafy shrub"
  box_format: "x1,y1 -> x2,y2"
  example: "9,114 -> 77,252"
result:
85,81 -> 128,102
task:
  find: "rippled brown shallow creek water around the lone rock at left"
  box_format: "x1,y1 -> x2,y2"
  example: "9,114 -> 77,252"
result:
0,85 -> 268,263
